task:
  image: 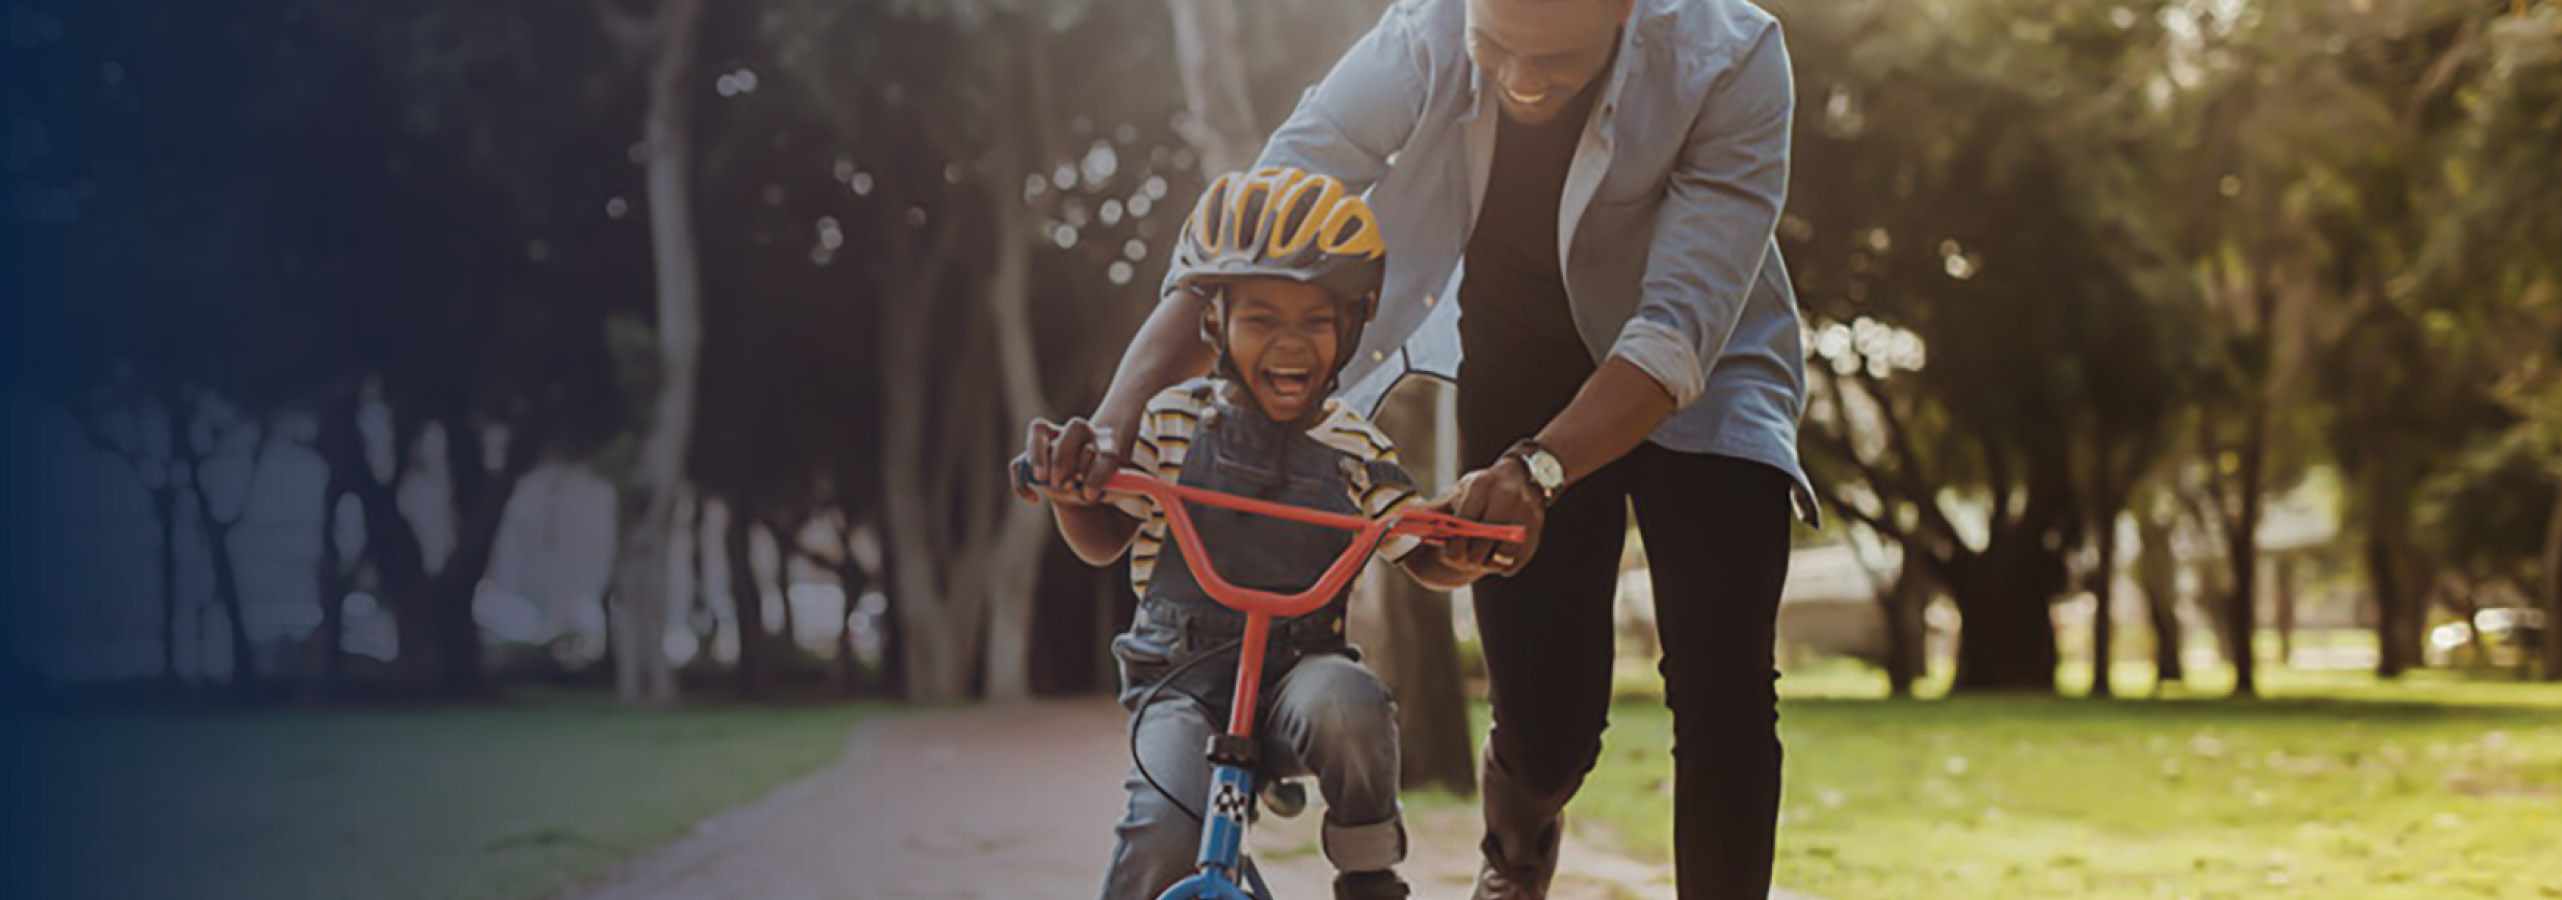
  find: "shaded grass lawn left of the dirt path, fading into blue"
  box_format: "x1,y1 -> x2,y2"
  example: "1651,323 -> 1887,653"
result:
0,695 -> 871,900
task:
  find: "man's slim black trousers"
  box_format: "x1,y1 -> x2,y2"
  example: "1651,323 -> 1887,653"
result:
1460,410 -> 1791,900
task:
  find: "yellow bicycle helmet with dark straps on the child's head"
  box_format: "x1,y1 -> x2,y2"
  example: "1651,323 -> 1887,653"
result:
1171,167 -> 1389,395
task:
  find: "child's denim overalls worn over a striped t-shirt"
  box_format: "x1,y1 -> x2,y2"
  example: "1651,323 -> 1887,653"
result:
1104,385 -> 1407,900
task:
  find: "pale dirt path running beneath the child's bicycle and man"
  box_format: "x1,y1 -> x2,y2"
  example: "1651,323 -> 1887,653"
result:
576,700 -> 1806,900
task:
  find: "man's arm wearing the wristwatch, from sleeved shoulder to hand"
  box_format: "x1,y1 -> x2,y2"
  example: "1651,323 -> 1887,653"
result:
1450,26 -> 1796,574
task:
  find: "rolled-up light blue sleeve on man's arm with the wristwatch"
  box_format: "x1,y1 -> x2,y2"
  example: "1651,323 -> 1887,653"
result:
1611,23 -> 1796,408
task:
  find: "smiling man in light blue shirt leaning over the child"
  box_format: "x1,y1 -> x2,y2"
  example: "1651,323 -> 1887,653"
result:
1043,0 -> 1814,900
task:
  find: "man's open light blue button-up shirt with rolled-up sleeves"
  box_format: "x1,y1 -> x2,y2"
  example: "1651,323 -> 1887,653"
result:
1229,0 -> 1814,521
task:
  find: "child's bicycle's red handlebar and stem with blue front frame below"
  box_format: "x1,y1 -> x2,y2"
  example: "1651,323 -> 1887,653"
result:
1015,459 -> 1524,900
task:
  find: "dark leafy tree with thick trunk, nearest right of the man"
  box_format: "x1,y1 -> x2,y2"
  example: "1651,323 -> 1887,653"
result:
1778,3 -> 2193,690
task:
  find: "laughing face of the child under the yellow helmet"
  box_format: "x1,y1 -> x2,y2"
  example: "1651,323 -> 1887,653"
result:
1225,277 -> 1340,421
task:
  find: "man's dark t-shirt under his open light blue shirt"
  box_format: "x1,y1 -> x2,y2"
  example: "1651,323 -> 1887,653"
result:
1458,62 -> 1604,467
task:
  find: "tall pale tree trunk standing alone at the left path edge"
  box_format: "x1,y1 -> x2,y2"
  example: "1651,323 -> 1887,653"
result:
612,0 -> 705,705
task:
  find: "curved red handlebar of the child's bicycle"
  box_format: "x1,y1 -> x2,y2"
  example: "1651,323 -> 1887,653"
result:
1015,459 -> 1527,618
